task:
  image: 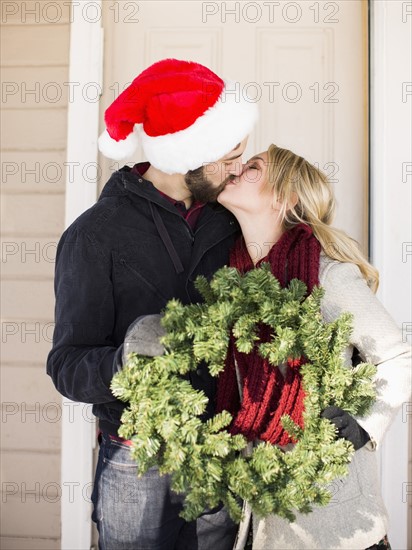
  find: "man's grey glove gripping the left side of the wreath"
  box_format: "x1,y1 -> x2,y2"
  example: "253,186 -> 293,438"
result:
115,314 -> 165,371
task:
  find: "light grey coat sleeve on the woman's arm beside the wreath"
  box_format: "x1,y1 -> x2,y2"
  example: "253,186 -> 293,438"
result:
319,257 -> 411,445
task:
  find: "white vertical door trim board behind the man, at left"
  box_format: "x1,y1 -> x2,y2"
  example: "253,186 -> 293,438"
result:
61,0 -> 103,550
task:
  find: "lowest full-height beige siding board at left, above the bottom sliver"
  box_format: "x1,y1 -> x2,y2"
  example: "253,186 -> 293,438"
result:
1,496 -> 60,537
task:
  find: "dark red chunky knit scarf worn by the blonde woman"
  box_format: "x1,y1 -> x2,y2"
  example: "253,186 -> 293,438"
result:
217,224 -> 321,445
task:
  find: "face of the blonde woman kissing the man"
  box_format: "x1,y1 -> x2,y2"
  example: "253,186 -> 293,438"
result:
217,151 -> 273,213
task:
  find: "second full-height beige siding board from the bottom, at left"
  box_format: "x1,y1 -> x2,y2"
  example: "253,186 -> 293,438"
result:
1,452 -> 61,500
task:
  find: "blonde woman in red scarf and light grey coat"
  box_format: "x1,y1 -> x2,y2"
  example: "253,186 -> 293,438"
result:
218,145 -> 411,550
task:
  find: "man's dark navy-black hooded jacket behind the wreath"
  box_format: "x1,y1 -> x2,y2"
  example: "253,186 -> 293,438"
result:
47,167 -> 238,434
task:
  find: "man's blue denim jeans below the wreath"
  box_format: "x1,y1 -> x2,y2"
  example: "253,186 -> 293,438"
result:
92,434 -> 238,550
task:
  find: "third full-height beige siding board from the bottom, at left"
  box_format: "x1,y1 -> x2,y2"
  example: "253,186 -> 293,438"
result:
0,402 -> 62,452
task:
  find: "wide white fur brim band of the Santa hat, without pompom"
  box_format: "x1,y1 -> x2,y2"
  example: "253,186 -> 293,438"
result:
140,83 -> 258,174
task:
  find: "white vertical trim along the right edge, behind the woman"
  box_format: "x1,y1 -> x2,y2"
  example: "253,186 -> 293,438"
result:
370,0 -> 412,550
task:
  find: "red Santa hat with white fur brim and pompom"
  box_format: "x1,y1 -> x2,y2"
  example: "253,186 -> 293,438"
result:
99,59 -> 257,174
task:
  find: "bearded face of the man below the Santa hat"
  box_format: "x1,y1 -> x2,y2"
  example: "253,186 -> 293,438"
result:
185,138 -> 247,202
